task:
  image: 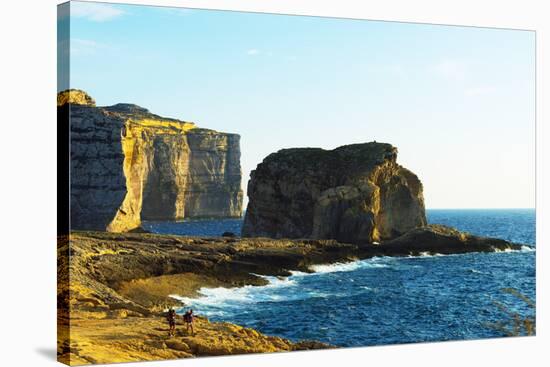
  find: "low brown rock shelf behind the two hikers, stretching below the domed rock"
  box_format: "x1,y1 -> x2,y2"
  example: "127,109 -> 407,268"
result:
58,230 -> 522,317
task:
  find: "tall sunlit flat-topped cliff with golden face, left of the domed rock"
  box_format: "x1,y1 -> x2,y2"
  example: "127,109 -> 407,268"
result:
58,91 -> 242,232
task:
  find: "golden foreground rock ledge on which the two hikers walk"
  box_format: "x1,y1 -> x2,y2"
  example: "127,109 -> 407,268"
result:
57,312 -> 331,366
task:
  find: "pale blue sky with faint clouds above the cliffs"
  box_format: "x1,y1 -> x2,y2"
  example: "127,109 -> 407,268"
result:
58,1 -> 535,208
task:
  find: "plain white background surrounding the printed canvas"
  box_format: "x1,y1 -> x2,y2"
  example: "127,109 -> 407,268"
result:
0,0 -> 550,367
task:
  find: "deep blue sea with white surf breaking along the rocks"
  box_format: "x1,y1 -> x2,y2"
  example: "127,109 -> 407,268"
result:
144,209 -> 536,347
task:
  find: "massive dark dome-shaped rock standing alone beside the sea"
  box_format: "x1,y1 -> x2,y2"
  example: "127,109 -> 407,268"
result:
242,143 -> 426,243
